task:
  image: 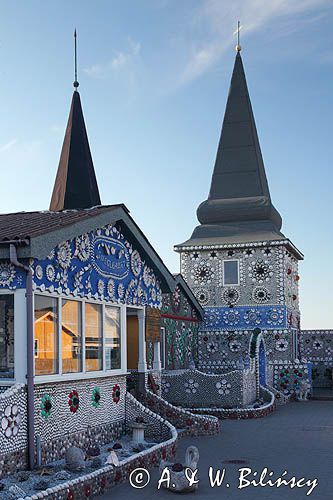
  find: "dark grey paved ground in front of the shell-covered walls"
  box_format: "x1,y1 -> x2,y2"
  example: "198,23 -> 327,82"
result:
99,401 -> 333,500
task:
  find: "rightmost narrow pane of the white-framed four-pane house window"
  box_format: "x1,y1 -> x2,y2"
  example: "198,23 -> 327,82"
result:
105,306 -> 121,370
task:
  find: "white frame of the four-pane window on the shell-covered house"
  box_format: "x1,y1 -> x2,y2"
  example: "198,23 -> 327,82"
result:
33,291 -> 127,384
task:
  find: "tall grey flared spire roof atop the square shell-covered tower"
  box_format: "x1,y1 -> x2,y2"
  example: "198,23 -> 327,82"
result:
176,52 -> 284,245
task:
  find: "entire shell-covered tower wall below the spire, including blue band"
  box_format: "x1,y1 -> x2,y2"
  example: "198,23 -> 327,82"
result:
181,242 -> 300,373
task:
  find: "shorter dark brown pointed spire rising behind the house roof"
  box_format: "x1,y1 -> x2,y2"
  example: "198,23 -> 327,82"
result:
50,90 -> 101,211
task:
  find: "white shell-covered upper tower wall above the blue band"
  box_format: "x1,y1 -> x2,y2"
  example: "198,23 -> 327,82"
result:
181,244 -> 299,309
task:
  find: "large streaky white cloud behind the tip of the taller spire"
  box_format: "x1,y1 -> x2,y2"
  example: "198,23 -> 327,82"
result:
178,0 -> 332,85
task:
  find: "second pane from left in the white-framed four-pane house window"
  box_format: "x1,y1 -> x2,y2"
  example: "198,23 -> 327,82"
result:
61,300 -> 82,373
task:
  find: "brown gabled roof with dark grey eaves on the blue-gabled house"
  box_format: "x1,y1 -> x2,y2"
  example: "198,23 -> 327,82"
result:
0,205 -> 175,293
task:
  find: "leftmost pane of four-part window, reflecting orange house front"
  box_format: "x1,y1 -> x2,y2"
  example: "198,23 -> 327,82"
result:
35,295 -> 58,375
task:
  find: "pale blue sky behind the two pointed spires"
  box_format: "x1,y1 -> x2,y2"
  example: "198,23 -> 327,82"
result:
0,0 -> 333,328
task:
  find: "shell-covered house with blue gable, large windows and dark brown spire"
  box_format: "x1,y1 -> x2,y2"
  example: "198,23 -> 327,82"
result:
0,89 -> 175,475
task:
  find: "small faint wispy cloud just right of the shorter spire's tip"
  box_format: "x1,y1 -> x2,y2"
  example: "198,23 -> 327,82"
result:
84,39 -> 141,78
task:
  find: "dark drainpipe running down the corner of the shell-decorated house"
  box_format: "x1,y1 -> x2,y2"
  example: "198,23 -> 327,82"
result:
9,243 -> 35,470
